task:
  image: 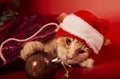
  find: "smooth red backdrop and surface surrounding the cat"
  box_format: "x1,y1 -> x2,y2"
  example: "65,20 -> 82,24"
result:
0,0 -> 120,79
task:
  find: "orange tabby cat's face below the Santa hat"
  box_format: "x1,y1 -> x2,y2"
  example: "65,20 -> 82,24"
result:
56,37 -> 90,64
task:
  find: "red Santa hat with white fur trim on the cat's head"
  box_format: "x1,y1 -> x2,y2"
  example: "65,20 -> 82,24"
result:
55,10 -> 109,54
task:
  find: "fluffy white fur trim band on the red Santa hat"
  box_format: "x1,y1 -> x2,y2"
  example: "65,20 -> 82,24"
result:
60,14 -> 104,54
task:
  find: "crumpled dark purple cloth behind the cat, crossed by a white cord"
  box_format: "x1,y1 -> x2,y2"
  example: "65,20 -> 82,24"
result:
0,14 -> 57,66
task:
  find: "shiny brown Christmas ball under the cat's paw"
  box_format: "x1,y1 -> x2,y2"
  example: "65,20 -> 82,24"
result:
25,52 -> 57,79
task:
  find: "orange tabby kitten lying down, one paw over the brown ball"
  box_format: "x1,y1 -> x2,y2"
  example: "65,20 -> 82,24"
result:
20,37 -> 94,67
